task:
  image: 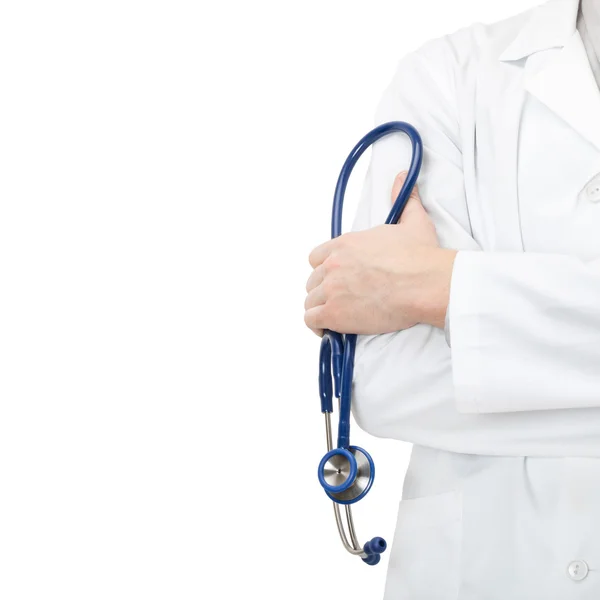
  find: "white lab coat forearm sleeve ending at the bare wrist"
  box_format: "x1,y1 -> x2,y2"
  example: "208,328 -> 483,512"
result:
448,251 -> 600,413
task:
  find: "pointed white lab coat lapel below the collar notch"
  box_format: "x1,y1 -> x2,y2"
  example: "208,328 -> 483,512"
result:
524,30 -> 600,150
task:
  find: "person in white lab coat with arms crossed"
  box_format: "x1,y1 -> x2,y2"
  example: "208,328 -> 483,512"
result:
305,0 -> 600,600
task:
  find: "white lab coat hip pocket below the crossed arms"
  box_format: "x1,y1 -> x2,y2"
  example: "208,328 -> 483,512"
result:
384,490 -> 462,600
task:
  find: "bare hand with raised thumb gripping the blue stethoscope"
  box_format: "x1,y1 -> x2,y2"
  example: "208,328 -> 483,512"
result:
304,172 -> 456,335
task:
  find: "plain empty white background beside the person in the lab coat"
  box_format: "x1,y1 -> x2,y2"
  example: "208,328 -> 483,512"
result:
0,0 -> 536,600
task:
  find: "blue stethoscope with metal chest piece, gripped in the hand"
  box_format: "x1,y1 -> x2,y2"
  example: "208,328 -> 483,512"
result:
319,121 -> 423,565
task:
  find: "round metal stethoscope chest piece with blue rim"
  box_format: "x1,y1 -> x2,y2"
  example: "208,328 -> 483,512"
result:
319,446 -> 375,504
